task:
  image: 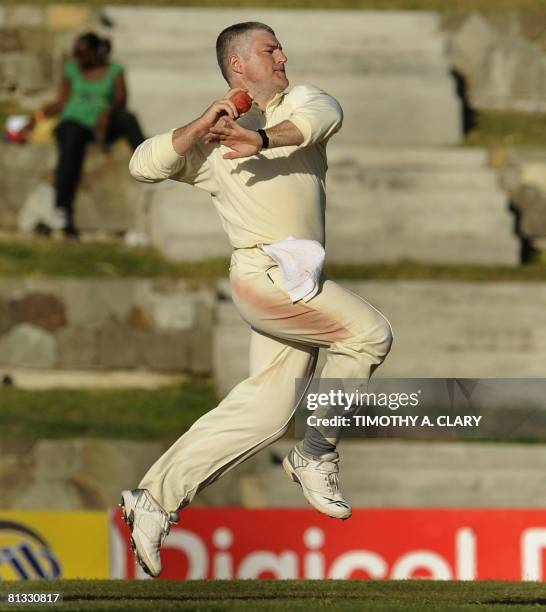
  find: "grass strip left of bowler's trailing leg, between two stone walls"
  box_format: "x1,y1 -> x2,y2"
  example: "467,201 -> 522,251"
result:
0,380 -> 217,441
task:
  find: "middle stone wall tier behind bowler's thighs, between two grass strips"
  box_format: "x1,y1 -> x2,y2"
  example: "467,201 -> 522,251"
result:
0,279 -> 546,378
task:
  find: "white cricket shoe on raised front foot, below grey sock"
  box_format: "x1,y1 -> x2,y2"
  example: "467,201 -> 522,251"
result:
282,442 -> 352,520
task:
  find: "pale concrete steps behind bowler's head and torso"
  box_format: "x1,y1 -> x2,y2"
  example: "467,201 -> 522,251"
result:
105,6 -> 508,263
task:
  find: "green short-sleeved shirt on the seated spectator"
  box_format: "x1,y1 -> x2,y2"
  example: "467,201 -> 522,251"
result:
60,60 -> 123,129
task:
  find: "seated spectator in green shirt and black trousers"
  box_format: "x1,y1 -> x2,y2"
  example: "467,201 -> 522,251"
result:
29,32 -> 144,238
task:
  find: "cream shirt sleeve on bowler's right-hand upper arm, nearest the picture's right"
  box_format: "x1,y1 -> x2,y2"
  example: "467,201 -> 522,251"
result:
287,85 -> 343,147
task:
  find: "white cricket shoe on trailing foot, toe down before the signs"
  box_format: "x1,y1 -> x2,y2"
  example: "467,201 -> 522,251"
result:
119,489 -> 178,578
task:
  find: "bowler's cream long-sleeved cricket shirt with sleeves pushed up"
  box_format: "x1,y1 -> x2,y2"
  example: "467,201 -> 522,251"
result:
129,85 -> 343,248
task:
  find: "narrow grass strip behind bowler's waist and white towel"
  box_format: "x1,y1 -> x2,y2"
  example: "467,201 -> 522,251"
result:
0,239 -> 546,283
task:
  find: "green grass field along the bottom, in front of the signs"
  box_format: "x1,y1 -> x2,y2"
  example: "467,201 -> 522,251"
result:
0,580 -> 546,612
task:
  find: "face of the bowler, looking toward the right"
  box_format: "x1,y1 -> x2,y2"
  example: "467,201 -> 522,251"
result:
241,30 -> 288,92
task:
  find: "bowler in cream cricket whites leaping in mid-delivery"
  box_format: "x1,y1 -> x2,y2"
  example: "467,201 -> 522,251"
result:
121,22 -> 392,576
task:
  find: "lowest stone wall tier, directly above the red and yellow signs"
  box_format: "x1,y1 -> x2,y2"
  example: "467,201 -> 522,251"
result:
0,439 -> 546,510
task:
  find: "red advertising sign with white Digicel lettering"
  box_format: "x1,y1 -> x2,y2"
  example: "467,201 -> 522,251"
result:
111,508 -> 546,581
